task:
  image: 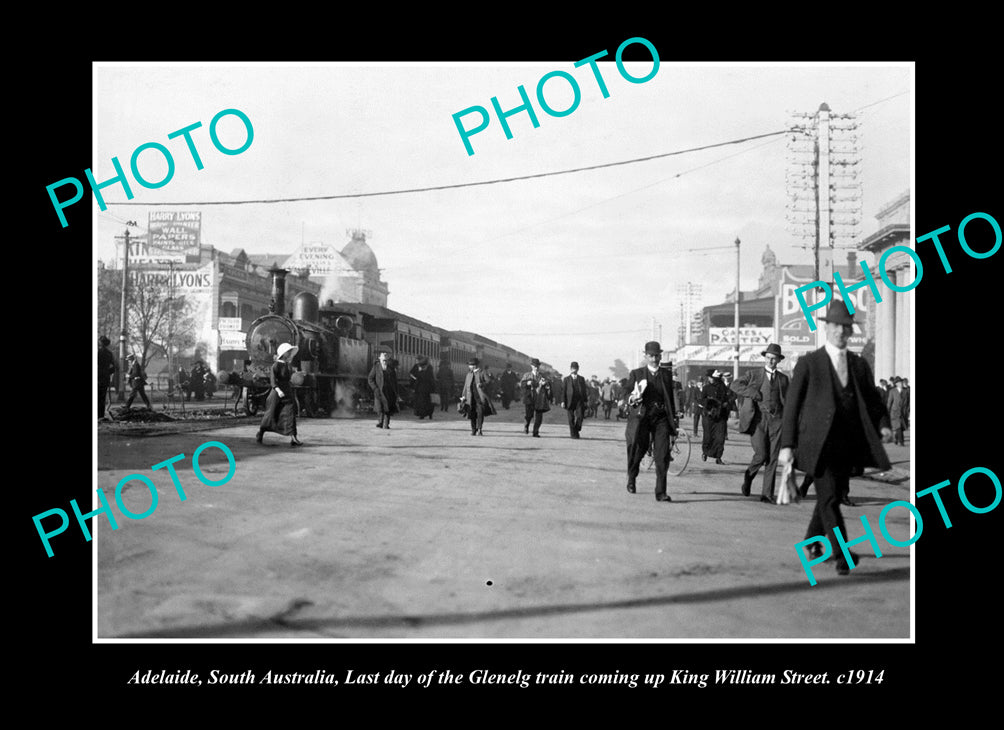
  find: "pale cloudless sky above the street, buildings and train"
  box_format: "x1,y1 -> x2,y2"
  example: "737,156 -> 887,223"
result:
92,59 -> 915,379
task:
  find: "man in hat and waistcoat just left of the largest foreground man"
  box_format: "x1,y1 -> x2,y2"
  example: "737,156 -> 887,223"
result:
730,342 -> 788,504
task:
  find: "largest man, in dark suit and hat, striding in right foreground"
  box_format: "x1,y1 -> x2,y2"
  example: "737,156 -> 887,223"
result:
778,301 -> 893,575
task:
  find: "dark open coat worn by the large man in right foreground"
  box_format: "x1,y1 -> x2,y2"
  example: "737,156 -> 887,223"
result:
781,347 -> 891,474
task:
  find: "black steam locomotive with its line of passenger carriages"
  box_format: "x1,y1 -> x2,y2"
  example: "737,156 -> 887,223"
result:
219,269 -> 549,416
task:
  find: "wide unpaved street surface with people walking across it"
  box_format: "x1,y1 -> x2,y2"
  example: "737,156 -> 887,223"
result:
92,409 -> 911,640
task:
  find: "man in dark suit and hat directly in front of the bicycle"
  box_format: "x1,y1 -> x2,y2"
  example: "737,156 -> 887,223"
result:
624,341 -> 677,502
